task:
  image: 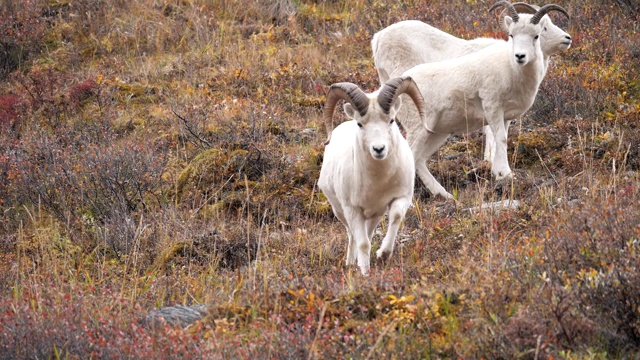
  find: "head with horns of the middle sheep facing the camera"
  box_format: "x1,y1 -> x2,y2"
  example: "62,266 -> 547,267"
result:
489,1 -> 569,66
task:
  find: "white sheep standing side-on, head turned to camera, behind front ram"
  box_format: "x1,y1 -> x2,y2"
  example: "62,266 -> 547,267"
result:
398,1 -> 568,198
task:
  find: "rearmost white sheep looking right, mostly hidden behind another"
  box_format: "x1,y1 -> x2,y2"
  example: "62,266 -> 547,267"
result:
371,3 -> 571,194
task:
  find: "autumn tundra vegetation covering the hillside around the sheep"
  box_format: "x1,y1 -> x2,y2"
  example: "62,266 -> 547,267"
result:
0,0 -> 640,359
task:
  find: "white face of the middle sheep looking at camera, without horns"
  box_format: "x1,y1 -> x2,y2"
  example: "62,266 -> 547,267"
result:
504,16 -> 549,66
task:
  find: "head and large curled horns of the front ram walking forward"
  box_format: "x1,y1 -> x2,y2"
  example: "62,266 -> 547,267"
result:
324,76 -> 425,160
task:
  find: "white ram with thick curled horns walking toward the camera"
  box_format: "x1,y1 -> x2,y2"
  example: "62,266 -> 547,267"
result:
318,77 -> 424,275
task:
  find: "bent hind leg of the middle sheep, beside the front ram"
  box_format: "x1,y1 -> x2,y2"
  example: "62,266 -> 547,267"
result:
409,132 -> 453,199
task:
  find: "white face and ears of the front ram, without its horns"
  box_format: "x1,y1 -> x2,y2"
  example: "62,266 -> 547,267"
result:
343,98 -> 401,161
